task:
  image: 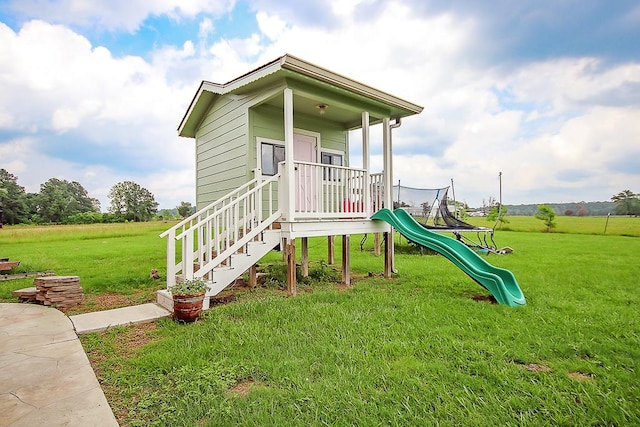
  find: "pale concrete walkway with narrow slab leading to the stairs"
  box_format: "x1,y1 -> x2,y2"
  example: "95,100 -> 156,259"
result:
0,303 -> 170,427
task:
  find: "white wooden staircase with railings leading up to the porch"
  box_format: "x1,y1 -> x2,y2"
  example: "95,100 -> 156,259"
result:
157,174 -> 281,310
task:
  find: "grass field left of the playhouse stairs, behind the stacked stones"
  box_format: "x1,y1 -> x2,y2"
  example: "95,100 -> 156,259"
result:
0,222 -> 175,302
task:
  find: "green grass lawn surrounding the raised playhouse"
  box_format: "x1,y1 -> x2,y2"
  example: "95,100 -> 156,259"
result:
0,218 -> 640,426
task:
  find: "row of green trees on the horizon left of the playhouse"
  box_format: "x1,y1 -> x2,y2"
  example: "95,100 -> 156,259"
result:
0,169 -> 193,226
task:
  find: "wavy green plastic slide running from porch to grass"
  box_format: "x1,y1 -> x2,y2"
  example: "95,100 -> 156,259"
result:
371,208 -> 526,307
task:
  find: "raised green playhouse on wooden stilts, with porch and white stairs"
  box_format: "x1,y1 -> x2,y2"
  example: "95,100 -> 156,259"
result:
158,55 -> 422,306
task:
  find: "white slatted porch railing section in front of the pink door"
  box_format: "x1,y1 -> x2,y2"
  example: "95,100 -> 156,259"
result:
294,161 -> 370,219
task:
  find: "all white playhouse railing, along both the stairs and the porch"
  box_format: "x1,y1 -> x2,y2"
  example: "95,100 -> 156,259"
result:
160,161 -> 384,289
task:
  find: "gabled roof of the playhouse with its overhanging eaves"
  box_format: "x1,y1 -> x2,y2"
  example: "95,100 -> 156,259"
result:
178,55 -> 422,138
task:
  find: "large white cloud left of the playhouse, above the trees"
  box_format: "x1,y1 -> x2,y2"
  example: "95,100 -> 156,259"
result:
0,21 -> 194,208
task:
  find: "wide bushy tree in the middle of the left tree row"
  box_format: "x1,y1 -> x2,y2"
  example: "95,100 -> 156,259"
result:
36,178 -> 100,223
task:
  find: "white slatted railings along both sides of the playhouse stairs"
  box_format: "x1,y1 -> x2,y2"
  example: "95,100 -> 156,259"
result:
160,174 -> 280,289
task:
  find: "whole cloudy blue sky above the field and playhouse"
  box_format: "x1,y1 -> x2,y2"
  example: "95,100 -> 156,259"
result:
0,0 -> 640,211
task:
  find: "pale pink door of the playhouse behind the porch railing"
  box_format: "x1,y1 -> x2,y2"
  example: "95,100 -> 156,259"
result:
293,133 -> 318,212
